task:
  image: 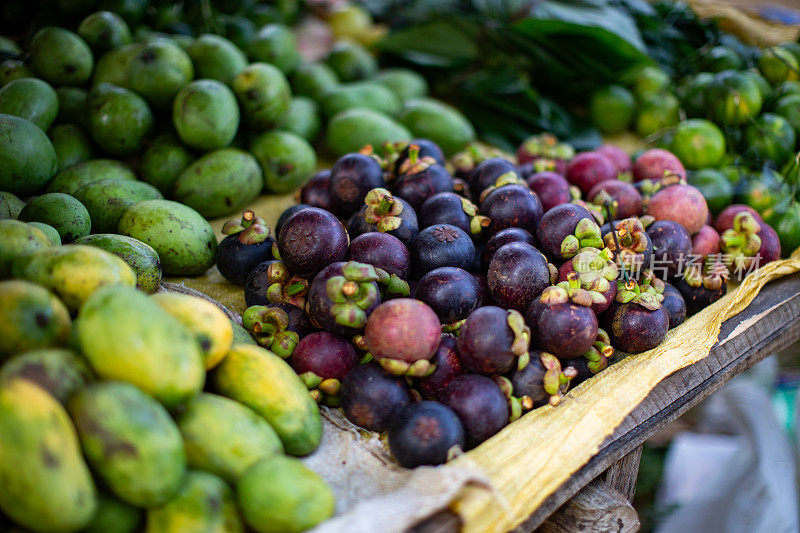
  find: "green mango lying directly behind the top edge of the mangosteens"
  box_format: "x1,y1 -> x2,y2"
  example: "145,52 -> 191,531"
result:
325,109 -> 412,156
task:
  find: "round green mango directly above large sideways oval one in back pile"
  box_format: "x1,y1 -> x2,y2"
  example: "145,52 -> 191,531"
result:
172,80 -> 239,150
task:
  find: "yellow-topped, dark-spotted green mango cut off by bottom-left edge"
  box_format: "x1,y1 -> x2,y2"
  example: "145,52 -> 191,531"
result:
0,379 -> 97,533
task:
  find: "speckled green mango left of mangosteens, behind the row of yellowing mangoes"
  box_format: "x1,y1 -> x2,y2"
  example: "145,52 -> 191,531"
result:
118,200 -> 217,276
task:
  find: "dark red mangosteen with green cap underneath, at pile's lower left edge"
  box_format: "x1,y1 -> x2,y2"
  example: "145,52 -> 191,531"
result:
289,331 -> 358,405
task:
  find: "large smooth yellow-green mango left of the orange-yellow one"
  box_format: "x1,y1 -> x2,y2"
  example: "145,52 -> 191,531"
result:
76,286 -> 205,407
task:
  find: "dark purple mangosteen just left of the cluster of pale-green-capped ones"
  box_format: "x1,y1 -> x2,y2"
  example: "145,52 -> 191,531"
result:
486,242 -> 550,312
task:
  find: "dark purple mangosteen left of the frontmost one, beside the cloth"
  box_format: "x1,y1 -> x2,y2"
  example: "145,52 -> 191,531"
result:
340,363 -> 411,432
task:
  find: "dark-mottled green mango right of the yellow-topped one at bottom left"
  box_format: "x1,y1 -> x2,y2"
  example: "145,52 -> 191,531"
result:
68,381 -> 186,507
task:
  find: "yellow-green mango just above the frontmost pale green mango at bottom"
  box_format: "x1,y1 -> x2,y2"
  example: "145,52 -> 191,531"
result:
178,393 -> 283,483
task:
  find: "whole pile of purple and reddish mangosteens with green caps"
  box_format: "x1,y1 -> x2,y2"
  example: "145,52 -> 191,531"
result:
217,135 -> 780,467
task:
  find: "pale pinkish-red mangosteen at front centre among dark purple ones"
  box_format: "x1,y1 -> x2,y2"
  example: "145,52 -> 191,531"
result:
364,298 -> 442,377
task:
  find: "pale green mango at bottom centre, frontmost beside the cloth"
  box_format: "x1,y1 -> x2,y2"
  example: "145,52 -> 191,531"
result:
236,456 -> 336,533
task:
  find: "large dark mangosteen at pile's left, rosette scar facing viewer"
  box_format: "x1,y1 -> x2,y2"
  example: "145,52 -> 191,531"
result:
278,207 -> 350,278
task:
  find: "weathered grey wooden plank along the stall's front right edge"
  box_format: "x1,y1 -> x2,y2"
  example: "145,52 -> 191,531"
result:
516,273 -> 800,531
